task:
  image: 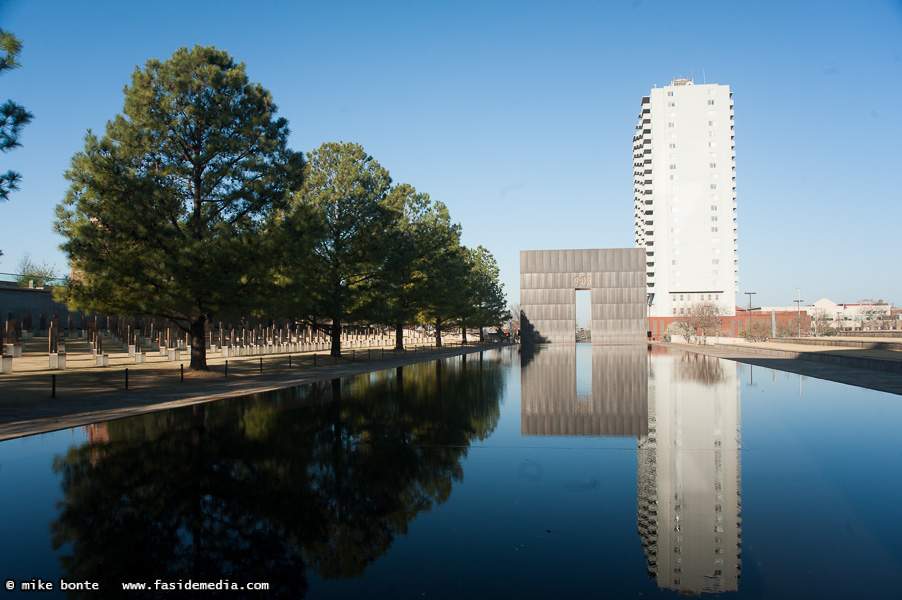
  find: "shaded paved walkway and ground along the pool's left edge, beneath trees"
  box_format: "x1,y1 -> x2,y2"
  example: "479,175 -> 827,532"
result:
0,344 -> 516,441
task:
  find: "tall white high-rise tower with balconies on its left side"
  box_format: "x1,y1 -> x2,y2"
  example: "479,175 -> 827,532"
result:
633,79 -> 739,317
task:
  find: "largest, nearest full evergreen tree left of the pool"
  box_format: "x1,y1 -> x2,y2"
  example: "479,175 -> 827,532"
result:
56,46 -> 303,369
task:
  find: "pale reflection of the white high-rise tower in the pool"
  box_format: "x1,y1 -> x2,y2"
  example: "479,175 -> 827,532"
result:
638,353 -> 742,594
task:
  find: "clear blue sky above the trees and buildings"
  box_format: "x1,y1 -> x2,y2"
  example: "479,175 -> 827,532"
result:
0,0 -> 902,306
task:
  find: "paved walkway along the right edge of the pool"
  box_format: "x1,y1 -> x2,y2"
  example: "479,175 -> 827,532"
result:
659,342 -> 902,395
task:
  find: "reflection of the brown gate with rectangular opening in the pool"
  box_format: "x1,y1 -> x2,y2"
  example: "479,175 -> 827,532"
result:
520,344 -> 648,436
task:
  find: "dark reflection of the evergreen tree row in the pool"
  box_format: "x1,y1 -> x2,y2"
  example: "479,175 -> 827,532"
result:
51,359 -> 502,597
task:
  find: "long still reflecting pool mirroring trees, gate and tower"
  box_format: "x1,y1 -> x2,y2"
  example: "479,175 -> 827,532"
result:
0,344 -> 902,599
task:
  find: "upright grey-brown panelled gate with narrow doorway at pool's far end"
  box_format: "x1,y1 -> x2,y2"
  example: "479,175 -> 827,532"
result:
520,248 -> 647,343
